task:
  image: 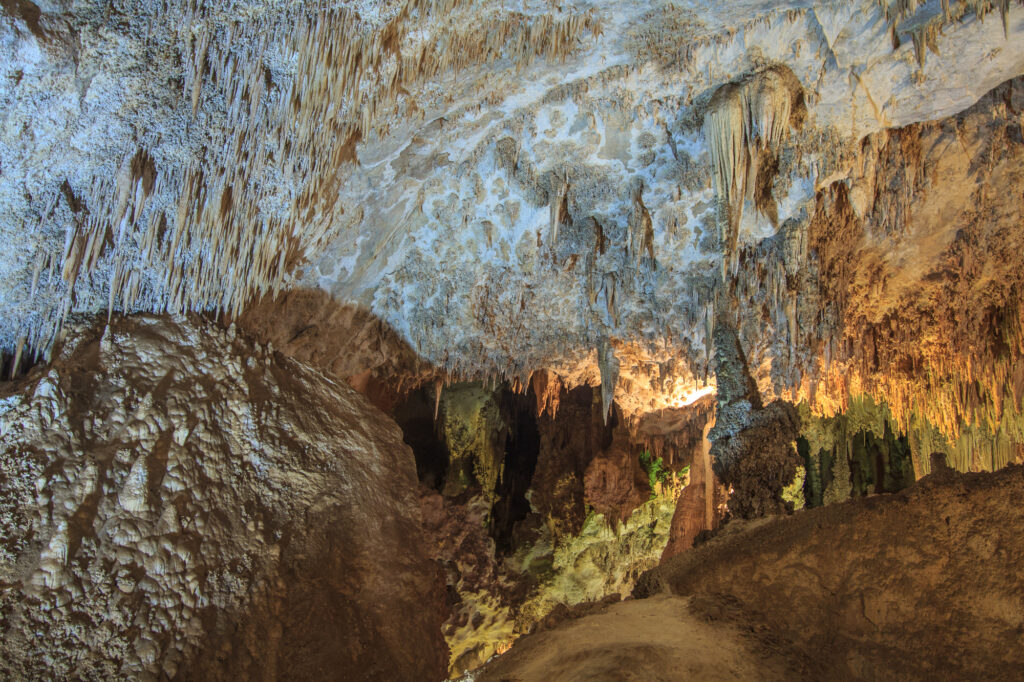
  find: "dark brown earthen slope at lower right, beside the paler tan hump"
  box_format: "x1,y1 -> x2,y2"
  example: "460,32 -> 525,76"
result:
635,464 -> 1024,680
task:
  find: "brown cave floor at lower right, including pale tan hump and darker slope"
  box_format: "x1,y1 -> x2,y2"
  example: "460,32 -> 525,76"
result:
476,466 -> 1024,681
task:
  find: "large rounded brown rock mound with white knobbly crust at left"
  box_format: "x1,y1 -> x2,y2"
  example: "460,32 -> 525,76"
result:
0,317 -> 445,680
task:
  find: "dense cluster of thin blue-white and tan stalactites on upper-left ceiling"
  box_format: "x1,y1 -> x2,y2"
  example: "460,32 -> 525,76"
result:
15,0 -> 600,366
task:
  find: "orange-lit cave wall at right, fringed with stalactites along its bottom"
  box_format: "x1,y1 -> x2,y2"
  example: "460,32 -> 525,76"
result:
729,79 -> 1024,476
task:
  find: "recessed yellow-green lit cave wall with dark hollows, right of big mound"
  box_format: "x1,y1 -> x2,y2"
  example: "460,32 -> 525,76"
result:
403,376 -> 712,677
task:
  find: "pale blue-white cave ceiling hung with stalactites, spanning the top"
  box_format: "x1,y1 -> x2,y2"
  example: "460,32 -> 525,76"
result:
6,0 -> 1024,415
